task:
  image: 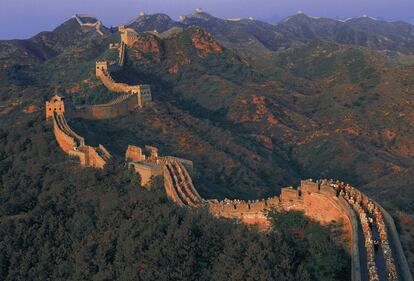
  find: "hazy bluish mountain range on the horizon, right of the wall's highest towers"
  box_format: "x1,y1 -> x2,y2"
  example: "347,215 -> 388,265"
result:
129,12 -> 414,54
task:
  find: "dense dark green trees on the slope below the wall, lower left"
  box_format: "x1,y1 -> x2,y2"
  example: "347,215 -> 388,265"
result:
0,110 -> 349,281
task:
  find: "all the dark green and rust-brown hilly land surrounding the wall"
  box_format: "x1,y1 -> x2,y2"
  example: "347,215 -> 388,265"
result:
0,9 -> 414,280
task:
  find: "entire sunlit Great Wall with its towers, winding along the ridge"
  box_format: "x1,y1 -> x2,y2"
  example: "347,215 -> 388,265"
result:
46,19 -> 413,281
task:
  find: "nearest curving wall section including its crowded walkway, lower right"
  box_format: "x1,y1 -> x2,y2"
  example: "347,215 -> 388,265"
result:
207,180 -> 412,281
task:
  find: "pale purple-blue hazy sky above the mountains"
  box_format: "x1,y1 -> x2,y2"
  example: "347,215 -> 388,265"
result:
0,0 -> 414,39
